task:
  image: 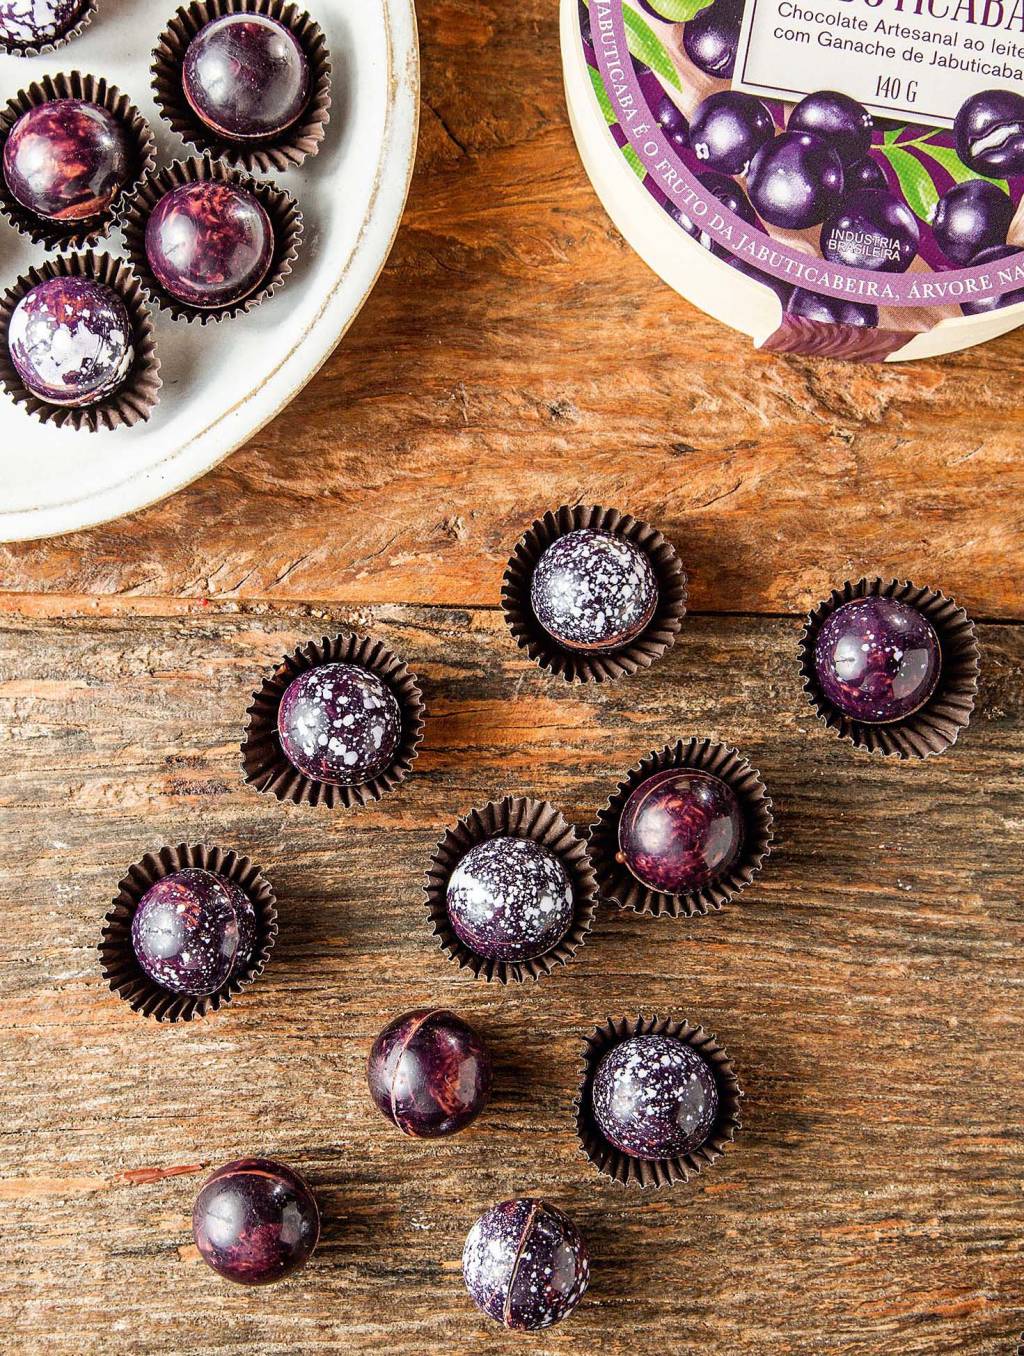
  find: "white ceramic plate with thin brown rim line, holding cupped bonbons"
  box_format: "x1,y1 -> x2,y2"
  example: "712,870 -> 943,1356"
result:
0,0 -> 419,541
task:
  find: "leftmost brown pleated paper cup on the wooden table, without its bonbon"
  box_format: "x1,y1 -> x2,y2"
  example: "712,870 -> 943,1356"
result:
99,843 -> 278,1022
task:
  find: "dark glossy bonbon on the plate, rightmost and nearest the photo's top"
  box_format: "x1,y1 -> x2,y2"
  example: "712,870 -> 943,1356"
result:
182,14 -> 309,141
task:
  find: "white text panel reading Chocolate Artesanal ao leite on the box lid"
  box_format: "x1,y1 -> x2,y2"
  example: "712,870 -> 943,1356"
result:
732,0 -> 1024,127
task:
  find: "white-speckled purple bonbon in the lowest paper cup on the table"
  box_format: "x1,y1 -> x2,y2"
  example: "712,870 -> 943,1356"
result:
590,1035 -> 719,1162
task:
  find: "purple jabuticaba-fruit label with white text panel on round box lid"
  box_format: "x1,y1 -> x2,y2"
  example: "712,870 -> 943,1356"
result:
579,0 -> 1024,335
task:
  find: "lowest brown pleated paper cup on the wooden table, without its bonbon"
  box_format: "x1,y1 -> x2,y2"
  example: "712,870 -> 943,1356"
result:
574,1017 -> 743,1191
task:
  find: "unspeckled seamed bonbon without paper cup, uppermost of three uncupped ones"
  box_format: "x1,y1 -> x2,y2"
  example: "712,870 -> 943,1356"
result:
366,1008 -> 491,1139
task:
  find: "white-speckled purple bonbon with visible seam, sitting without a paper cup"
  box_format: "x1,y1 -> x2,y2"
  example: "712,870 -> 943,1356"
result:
462,1200 -> 590,1332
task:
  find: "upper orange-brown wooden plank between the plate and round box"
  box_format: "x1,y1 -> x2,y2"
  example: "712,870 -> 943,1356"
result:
0,0 -> 1024,618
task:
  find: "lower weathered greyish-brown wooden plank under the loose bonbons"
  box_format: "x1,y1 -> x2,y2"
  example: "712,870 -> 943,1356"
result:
0,601 -> 1024,1356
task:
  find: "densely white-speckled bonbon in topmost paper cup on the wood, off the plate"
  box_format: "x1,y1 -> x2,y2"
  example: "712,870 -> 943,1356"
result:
530,527 -> 658,651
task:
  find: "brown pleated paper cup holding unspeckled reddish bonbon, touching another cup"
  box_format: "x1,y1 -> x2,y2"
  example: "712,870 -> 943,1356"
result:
590,738 -> 774,918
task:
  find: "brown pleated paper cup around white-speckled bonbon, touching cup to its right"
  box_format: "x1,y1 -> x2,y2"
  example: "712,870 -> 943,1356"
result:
425,796 -> 597,984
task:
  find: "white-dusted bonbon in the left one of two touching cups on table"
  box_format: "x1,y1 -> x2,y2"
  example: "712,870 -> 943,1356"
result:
448,838 -> 574,961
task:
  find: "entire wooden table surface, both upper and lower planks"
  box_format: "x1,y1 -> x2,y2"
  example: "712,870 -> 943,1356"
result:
0,0 -> 1024,1356
